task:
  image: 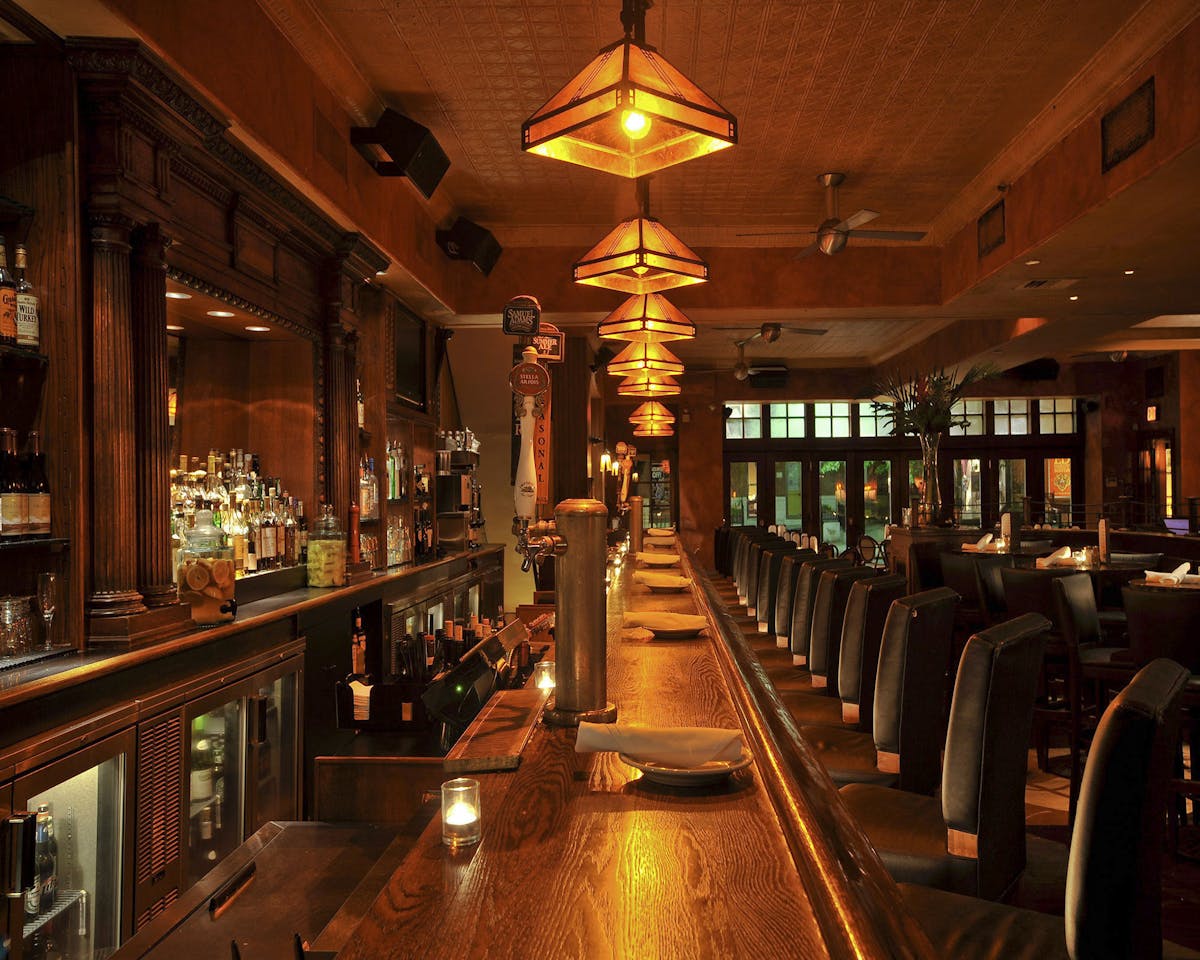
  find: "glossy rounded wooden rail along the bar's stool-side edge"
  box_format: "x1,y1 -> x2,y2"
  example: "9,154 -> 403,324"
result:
685,558 -> 932,958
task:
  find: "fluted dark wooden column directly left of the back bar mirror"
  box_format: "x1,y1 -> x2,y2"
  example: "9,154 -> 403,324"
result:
132,223 -> 179,607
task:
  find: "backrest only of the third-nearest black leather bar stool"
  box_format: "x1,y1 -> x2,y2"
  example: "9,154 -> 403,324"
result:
872,587 -> 959,793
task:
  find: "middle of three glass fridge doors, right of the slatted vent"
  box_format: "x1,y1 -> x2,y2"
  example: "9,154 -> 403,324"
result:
184,688 -> 246,888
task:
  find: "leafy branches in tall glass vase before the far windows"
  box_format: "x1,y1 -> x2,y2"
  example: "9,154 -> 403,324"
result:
874,366 -> 991,522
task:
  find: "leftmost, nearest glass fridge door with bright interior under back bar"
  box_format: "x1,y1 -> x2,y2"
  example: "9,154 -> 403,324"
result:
10,732 -> 134,960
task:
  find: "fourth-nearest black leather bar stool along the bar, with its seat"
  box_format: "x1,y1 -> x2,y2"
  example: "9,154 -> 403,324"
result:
786,576 -> 907,733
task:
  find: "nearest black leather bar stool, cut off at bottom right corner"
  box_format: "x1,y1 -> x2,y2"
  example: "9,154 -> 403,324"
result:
900,660 -> 1187,960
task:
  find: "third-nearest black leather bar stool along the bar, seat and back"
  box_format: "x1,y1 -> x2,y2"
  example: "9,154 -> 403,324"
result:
785,587 -> 959,794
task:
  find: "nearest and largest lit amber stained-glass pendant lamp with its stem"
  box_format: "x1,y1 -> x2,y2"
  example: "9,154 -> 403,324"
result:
521,0 -> 738,178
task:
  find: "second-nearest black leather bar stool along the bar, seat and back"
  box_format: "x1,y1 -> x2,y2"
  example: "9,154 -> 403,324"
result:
841,613 -> 1050,900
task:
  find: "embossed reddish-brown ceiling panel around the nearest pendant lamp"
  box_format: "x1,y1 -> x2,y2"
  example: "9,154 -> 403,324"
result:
308,0 -> 1140,245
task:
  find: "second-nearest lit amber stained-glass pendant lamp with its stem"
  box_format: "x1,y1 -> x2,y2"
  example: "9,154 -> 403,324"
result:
571,207 -> 708,294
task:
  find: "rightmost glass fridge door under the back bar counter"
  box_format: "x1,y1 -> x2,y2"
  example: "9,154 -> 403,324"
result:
245,664 -> 300,836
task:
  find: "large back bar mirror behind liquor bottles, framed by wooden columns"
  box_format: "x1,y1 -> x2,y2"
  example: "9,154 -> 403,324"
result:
167,273 -> 319,552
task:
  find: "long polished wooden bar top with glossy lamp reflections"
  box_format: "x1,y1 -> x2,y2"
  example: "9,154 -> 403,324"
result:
338,562 -> 920,960
